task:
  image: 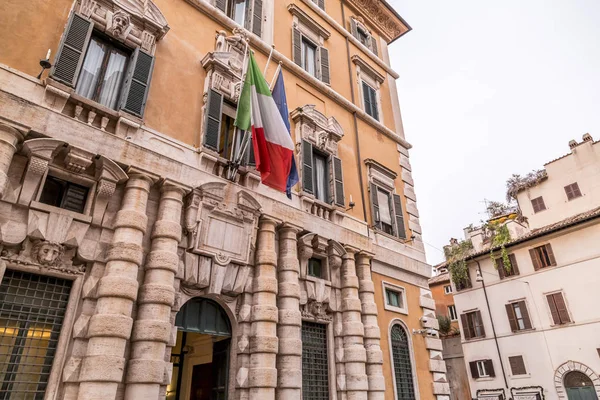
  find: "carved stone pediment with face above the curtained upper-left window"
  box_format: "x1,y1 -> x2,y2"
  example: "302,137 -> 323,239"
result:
76,0 -> 169,53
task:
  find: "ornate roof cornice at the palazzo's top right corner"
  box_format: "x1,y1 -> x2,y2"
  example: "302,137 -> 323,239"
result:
348,0 -> 411,43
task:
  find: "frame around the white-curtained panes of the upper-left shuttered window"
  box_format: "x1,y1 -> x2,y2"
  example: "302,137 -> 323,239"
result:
73,33 -> 135,111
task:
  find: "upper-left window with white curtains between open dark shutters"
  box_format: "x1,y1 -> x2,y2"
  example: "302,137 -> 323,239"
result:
75,37 -> 129,109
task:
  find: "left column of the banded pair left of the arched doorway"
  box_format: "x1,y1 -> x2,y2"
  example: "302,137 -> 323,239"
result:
77,171 -> 153,400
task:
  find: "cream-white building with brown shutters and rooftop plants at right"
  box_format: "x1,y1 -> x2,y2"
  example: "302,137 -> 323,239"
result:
454,134 -> 600,400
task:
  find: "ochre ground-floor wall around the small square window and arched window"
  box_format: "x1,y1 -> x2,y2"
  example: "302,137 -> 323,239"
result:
372,273 -> 435,400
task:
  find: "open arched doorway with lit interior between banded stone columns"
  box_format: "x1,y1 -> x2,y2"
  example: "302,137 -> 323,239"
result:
166,298 -> 231,400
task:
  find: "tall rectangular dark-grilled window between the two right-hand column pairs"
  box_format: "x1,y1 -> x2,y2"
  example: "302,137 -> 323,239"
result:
302,321 -> 329,400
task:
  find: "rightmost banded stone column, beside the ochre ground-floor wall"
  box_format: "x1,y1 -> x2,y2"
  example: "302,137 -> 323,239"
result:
356,252 -> 385,400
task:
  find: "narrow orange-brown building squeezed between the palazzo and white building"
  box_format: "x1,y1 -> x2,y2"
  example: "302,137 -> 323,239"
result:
429,265 -> 471,400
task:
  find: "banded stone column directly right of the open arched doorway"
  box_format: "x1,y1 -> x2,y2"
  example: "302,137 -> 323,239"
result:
248,217 -> 279,400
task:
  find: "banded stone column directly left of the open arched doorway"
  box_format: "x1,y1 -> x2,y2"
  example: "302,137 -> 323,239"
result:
125,181 -> 185,400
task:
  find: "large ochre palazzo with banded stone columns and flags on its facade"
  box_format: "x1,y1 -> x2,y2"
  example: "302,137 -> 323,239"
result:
0,0 -> 448,400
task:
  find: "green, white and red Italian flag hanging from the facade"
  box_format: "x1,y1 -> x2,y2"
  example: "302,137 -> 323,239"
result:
235,52 -> 294,192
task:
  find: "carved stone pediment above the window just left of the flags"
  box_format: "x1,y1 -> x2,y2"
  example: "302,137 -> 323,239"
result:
202,28 -> 249,103
